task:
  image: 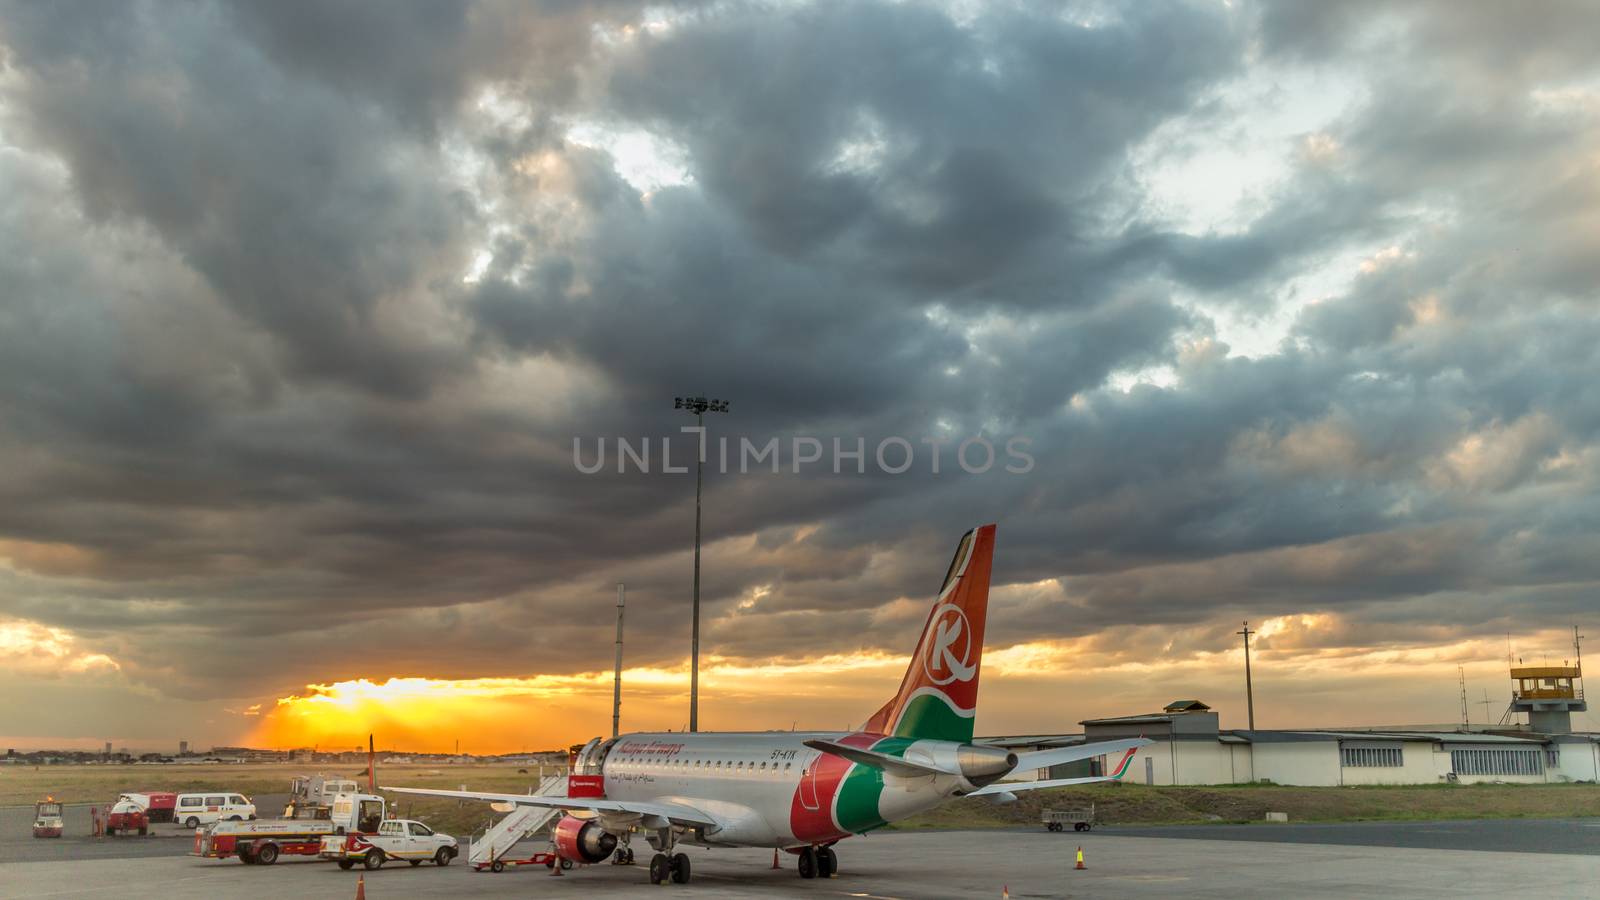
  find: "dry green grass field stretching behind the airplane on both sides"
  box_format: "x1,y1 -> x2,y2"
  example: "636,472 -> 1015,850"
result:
0,764 -> 1600,834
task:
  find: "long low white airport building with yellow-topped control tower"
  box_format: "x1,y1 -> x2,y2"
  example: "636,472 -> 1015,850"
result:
979,656 -> 1600,786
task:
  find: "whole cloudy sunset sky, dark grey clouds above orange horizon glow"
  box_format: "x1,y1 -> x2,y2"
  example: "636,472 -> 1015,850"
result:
0,0 -> 1600,753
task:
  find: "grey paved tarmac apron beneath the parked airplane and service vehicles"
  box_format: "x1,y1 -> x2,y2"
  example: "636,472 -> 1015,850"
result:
0,820 -> 1600,900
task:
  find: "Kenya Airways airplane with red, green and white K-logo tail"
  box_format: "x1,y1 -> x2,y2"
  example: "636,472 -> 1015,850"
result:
395,524 -> 1150,884
